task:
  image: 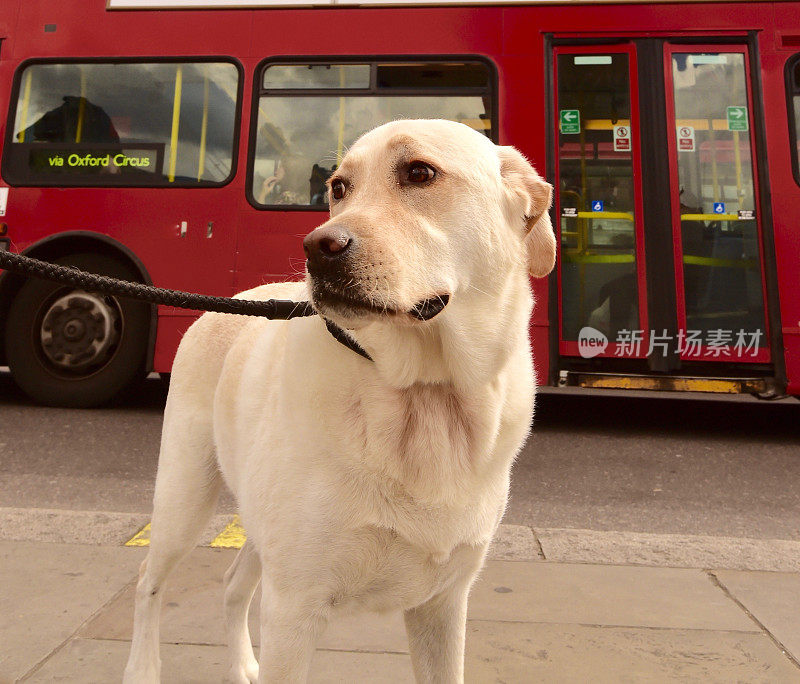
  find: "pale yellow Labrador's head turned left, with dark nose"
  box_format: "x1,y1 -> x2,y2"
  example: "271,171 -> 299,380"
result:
303,120 -> 556,340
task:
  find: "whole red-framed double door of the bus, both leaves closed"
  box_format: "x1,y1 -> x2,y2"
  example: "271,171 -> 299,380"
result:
554,39 -> 770,389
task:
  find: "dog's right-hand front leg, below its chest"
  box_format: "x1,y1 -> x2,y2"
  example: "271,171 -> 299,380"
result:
404,581 -> 471,684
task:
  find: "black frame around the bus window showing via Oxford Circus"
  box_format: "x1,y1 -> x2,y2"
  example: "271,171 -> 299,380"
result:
0,55 -> 245,190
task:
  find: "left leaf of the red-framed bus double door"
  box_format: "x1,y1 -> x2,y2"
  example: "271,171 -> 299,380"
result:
555,45 -> 649,359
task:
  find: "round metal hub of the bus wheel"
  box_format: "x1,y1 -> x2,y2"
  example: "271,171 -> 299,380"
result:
41,290 -> 120,371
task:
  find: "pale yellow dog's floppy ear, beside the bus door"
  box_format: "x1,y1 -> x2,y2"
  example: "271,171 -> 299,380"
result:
497,147 -> 556,278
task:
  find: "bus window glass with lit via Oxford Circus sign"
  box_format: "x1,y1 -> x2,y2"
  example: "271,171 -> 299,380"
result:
3,62 -> 239,186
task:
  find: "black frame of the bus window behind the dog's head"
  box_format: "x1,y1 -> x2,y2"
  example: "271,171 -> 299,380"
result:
245,53 -> 500,212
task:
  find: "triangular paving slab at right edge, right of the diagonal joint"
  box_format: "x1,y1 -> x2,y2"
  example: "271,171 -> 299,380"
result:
714,571 -> 800,664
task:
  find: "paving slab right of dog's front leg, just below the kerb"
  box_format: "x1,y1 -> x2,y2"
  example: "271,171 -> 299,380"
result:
469,561 -> 758,632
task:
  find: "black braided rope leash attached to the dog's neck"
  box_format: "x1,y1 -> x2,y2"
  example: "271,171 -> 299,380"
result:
0,250 -> 372,361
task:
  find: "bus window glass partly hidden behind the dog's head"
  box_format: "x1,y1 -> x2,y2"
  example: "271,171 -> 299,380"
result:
251,62 -> 493,208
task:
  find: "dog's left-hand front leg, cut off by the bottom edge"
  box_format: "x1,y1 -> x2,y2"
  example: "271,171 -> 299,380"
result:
258,573 -> 332,684
